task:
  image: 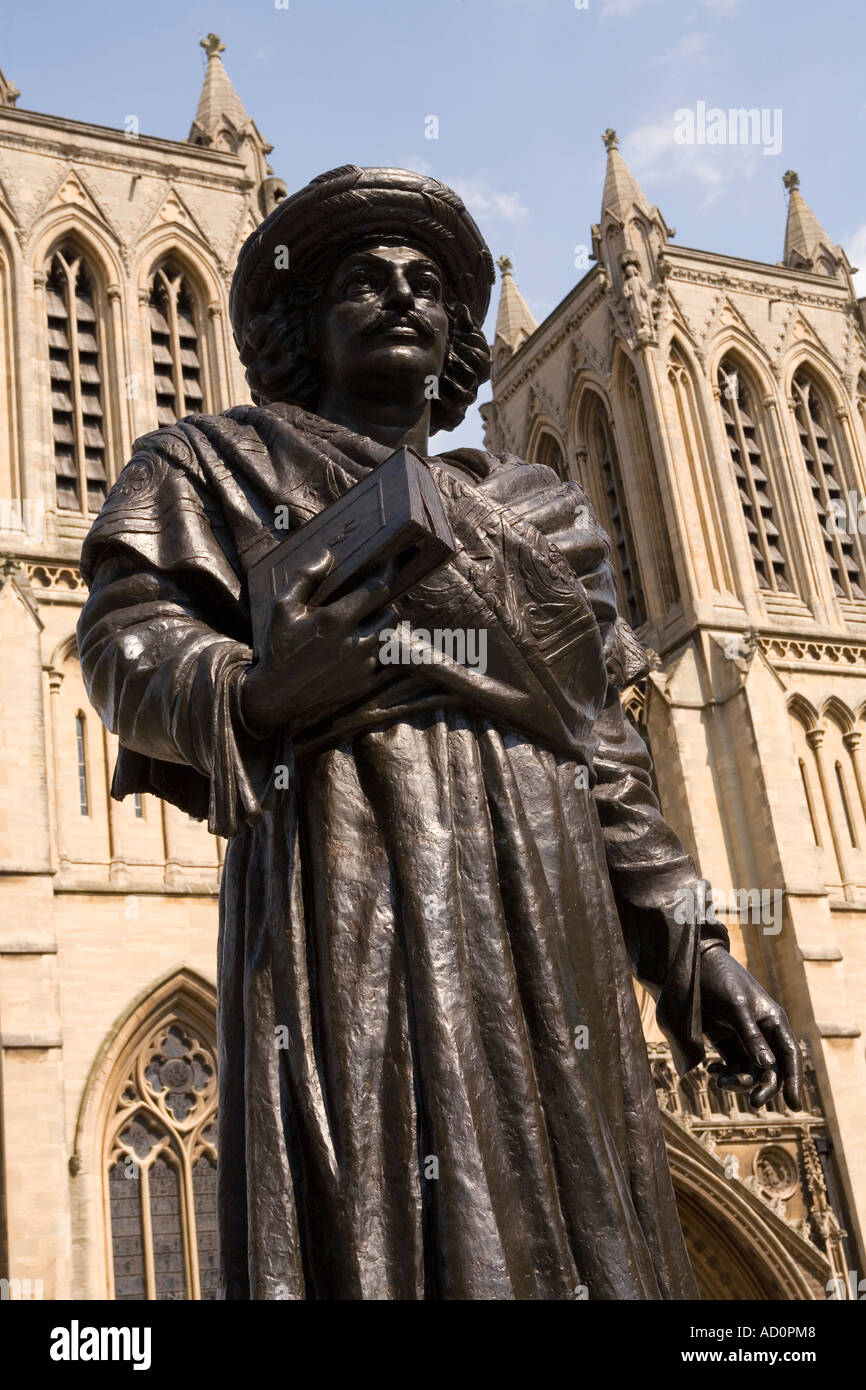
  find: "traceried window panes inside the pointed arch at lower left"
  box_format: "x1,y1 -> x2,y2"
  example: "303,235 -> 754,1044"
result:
104,1016 -> 218,1300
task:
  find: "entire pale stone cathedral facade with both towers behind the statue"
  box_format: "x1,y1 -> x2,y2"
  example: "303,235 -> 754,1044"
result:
0,43 -> 866,1300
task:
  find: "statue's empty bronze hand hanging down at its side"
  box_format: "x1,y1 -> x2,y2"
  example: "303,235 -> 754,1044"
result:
701,947 -> 803,1111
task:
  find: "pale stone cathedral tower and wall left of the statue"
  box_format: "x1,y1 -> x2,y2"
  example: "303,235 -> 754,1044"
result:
0,35 -> 285,1298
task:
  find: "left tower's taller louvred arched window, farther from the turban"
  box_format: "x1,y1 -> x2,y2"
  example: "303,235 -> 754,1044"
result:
46,246 -> 107,516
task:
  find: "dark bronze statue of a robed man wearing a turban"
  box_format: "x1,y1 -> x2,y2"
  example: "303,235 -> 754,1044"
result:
78,165 -> 799,1300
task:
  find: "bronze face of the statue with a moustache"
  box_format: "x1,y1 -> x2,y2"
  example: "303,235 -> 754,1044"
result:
317,246 -> 449,403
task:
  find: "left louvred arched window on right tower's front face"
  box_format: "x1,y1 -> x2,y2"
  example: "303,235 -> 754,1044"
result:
719,356 -> 792,594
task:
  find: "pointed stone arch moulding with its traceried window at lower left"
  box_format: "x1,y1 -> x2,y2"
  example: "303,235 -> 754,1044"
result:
75,967 -> 217,1300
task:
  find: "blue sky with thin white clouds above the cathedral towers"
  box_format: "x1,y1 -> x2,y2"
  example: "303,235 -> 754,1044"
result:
0,0 -> 866,446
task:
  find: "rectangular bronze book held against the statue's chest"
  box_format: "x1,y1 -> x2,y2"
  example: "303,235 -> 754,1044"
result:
247,448 -> 456,655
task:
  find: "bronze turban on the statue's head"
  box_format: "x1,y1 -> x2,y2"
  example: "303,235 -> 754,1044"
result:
228,164 -> 495,348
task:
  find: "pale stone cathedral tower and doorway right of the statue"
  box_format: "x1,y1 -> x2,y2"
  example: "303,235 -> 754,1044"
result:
482,131 -> 866,1298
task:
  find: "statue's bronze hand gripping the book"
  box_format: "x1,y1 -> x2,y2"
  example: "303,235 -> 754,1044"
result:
240,550 -> 393,730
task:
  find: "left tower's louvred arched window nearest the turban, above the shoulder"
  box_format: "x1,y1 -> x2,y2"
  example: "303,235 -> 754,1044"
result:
149,261 -> 207,425
